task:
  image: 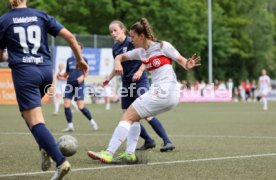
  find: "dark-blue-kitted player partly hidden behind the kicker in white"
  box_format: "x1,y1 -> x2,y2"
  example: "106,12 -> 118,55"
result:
104,20 -> 175,152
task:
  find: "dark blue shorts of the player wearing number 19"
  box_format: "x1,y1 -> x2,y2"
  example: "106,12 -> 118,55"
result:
12,65 -> 53,111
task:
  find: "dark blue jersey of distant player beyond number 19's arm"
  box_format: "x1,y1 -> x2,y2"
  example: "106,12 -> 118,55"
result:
66,56 -> 88,83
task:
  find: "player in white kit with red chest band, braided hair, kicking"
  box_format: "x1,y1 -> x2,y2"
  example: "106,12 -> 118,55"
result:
87,18 -> 200,163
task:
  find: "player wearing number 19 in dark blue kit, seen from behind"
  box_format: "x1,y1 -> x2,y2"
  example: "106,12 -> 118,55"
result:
0,0 -> 88,179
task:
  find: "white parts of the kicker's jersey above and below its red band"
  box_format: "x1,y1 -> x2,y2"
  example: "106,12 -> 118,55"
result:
126,41 -> 180,84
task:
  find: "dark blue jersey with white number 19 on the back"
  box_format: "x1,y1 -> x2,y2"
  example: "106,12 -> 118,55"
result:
0,8 -> 63,67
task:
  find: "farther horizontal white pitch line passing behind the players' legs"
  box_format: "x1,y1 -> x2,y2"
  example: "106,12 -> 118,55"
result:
0,132 -> 276,139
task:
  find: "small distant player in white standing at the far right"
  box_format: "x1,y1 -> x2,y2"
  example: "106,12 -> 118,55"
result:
259,69 -> 270,110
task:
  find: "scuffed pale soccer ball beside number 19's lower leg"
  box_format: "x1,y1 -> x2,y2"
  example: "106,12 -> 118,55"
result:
57,135 -> 78,157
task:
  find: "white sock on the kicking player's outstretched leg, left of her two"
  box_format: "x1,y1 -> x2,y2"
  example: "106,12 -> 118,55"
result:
106,121 -> 130,156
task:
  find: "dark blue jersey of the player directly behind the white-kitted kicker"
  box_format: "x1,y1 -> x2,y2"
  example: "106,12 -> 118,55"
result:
112,36 -> 147,81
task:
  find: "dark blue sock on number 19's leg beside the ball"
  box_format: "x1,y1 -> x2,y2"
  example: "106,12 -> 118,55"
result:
31,123 -> 65,166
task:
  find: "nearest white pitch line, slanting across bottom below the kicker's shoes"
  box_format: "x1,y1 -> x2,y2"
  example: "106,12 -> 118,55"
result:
0,153 -> 276,178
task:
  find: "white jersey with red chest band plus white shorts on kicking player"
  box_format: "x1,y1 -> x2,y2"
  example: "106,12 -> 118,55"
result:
126,42 -> 180,118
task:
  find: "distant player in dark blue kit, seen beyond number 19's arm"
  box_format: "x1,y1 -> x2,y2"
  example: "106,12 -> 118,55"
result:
58,43 -> 98,132
